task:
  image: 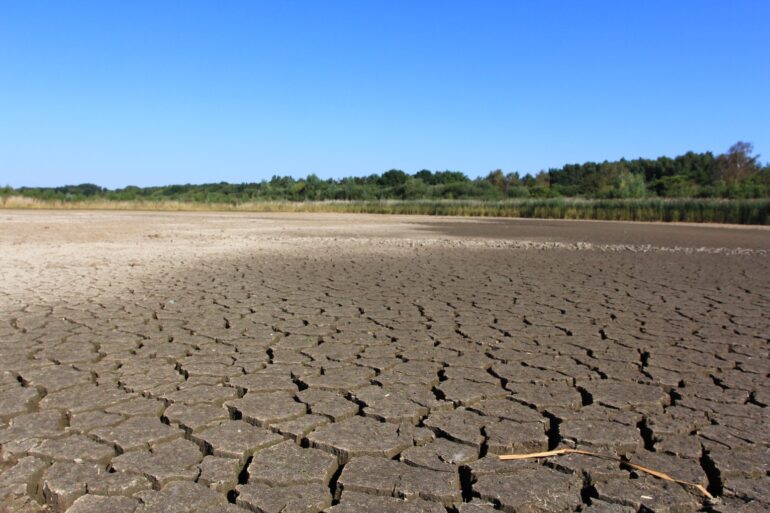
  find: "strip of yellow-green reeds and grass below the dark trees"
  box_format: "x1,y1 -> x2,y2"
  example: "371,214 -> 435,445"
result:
0,196 -> 770,224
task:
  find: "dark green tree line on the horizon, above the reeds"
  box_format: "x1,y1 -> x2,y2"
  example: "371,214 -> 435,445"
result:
0,142 -> 770,203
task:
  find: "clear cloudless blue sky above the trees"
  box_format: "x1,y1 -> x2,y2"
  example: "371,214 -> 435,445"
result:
0,0 -> 770,187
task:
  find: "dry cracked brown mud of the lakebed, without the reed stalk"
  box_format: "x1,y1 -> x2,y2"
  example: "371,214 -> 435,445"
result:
0,211 -> 770,513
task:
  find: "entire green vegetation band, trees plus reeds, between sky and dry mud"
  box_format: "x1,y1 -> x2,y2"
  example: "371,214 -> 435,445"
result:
7,142 -> 770,224
